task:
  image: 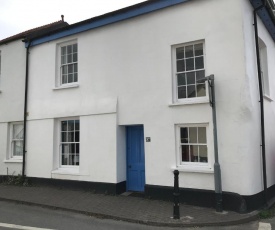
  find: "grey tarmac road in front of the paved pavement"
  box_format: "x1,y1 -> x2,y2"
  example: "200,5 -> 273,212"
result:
0,201 -> 275,230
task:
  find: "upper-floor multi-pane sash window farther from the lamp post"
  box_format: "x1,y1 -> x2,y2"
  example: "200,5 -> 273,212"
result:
60,43 -> 78,85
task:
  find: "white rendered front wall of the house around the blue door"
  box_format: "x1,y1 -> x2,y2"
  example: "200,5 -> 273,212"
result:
21,0 -> 272,195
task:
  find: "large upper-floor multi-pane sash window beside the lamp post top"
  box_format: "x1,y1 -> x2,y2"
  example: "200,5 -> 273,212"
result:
173,42 -> 206,100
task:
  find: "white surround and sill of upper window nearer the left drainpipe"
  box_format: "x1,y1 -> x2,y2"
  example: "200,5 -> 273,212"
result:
54,39 -> 79,89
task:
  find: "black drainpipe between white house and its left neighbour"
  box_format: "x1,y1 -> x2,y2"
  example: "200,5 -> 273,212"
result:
22,40 -> 31,180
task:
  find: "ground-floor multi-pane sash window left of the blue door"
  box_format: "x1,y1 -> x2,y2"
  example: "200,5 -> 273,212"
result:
60,120 -> 80,166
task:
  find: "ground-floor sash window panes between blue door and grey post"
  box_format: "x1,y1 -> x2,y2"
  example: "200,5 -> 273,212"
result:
179,127 -> 208,164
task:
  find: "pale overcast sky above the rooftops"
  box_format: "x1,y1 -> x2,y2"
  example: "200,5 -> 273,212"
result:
0,0 -> 145,40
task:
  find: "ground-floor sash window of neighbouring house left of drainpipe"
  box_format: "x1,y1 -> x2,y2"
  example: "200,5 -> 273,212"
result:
11,123 -> 24,158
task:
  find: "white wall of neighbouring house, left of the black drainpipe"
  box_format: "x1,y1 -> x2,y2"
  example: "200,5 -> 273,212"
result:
0,40 -> 26,175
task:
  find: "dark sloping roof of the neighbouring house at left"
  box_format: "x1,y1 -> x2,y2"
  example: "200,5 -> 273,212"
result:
0,20 -> 69,45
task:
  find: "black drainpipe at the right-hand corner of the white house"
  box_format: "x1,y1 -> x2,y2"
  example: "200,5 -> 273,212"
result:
253,0 -> 268,207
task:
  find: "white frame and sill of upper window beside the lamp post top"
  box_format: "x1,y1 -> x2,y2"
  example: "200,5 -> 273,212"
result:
172,40 -> 209,105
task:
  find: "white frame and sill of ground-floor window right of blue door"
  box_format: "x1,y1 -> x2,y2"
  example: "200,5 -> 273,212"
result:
175,123 -> 214,173
